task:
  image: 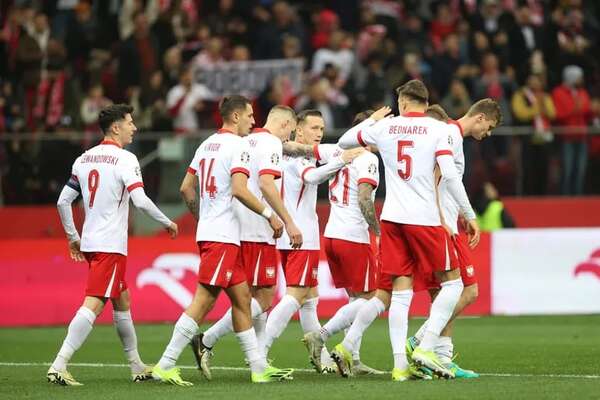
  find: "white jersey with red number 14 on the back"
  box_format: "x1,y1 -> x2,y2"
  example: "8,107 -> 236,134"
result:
188,129 -> 250,246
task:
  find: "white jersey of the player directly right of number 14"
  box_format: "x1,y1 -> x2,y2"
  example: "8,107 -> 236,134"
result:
234,129 -> 283,244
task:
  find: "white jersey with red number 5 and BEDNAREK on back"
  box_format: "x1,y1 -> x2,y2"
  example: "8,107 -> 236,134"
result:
343,112 -> 452,226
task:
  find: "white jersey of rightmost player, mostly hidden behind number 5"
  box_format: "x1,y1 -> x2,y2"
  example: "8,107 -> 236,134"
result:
438,120 -> 465,234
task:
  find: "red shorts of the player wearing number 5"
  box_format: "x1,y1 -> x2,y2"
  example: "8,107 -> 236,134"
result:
380,221 -> 458,289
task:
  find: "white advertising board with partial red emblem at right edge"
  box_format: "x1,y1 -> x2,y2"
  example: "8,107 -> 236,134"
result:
491,228 -> 600,315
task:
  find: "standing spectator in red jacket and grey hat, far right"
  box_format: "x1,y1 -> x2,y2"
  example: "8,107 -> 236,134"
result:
552,65 -> 590,195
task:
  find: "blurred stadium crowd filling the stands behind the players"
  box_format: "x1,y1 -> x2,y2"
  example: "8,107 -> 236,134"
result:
0,0 -> 600,204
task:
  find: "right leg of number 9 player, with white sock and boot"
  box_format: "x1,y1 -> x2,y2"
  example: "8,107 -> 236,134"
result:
111,289 -> 152,382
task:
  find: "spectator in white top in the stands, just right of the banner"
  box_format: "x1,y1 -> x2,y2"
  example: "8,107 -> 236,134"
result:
312,31 -> 354,87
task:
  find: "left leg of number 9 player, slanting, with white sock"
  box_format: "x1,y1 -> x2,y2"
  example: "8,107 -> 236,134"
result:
47,296 -> 106,386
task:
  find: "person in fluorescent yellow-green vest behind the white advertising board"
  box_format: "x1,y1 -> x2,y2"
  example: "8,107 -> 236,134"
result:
474,182 -> 515,232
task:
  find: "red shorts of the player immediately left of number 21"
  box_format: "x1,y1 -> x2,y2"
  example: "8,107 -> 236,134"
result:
280,250 -> 319,287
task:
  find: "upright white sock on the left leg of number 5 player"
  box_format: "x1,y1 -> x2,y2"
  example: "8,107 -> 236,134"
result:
388,289 -> 413,370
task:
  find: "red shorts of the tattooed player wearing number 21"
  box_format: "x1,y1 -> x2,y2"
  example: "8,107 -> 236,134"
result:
325,238 -> 378,292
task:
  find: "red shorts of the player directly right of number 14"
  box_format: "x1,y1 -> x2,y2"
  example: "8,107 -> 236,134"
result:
240,242 -> 279,287
